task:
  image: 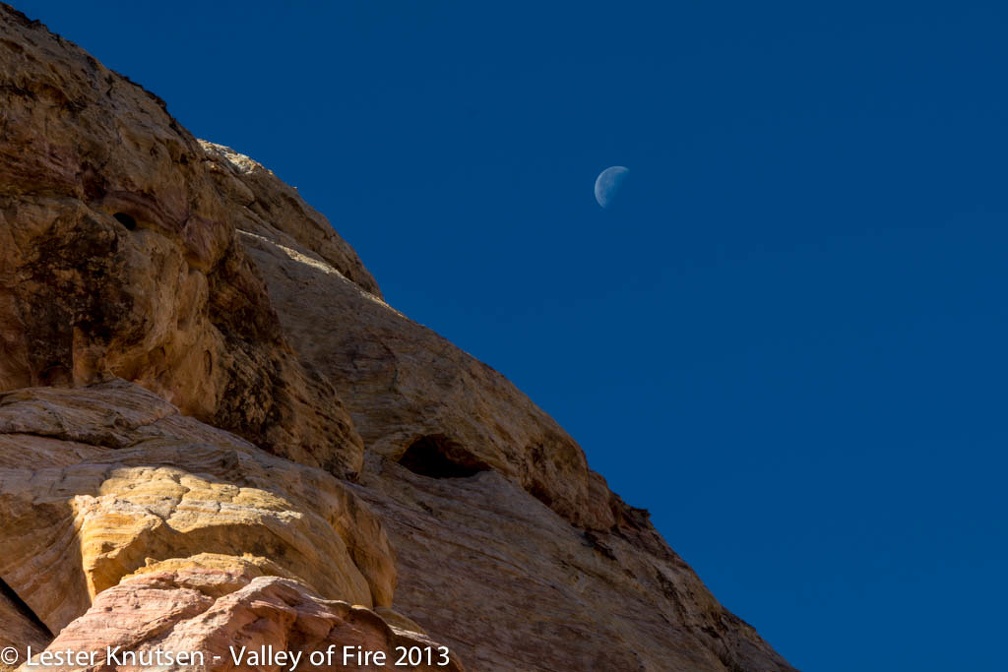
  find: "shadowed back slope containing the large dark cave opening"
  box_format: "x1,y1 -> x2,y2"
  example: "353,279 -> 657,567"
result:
218,153 -> 791,672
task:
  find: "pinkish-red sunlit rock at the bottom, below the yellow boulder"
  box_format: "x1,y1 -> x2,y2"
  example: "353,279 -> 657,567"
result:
37,559 -> 463,672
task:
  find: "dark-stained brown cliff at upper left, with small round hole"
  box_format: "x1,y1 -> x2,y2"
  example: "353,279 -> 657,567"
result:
0,9 -> 362,475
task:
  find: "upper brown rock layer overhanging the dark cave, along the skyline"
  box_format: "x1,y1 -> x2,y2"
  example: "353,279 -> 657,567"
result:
211,143 -> 623,529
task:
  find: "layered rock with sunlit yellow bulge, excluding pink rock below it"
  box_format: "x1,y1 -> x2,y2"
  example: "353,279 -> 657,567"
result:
0,381 -> 396,633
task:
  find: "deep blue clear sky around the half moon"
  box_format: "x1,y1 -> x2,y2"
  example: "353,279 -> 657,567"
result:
16,0 -> 1008,672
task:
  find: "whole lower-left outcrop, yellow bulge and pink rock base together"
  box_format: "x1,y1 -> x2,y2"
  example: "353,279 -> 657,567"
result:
0,381 -> 461,670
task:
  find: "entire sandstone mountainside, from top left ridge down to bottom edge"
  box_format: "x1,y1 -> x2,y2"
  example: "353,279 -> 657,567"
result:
0,5 -> 792,672
